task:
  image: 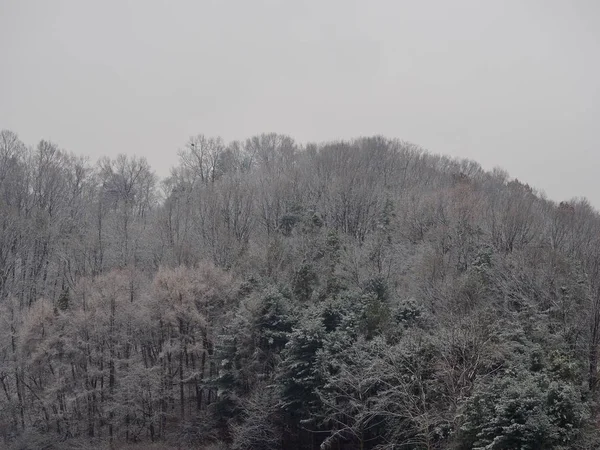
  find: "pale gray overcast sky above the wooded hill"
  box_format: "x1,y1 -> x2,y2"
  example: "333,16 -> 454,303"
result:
0,0 -> 600,207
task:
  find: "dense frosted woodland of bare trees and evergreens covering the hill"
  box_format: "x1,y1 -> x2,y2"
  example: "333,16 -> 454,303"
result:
0,127 -> 600,450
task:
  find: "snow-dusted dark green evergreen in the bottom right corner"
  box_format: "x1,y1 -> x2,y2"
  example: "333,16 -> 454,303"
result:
458,314 -> 591,449
